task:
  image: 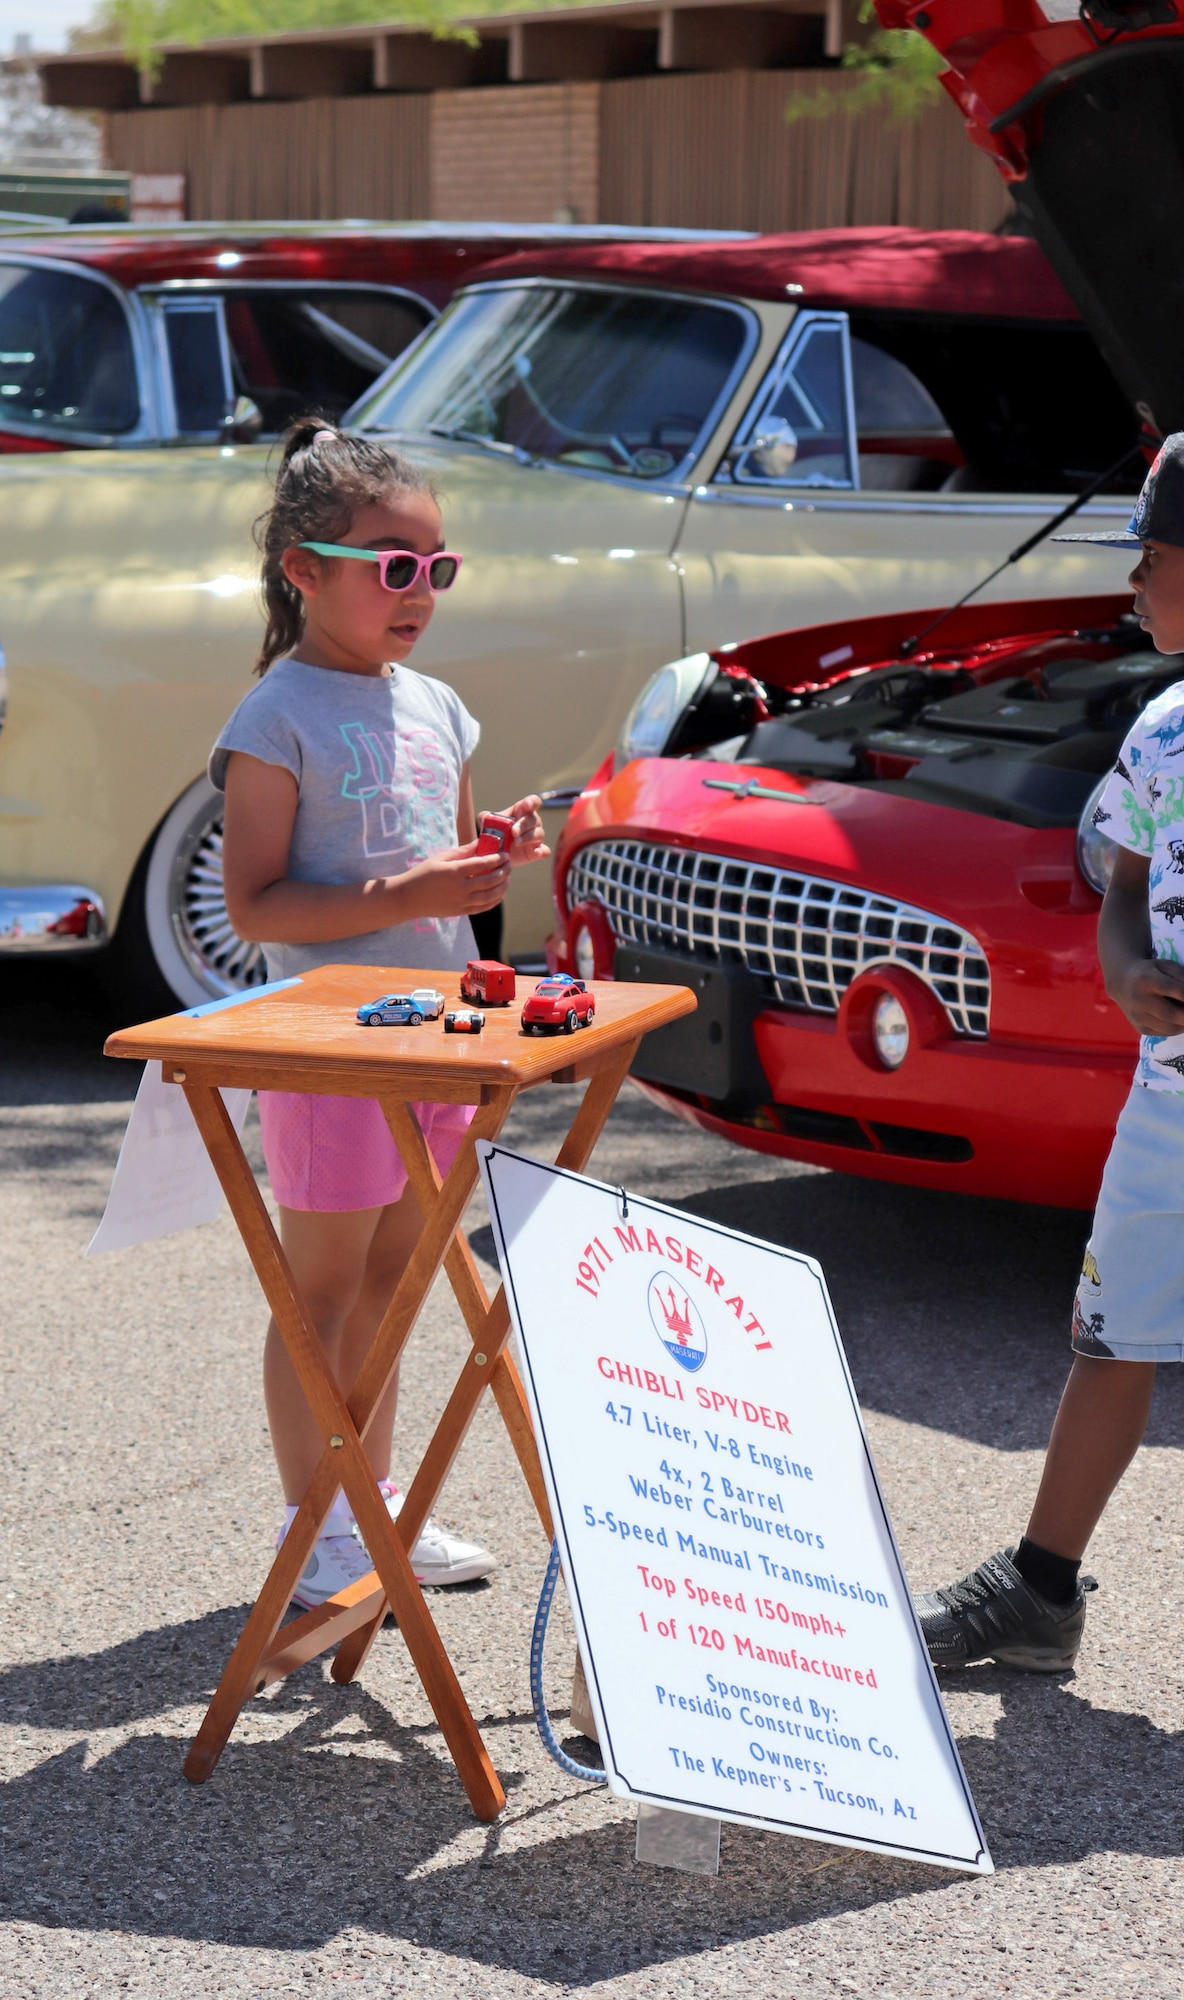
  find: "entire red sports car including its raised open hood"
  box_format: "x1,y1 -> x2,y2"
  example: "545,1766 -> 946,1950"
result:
550,0 -> 1184,1208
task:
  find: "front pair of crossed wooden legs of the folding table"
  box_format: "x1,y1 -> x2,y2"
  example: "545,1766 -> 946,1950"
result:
186,1084 -> 514,1818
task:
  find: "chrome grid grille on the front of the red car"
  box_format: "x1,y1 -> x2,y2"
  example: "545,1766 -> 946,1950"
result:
566,840 -> 990,1036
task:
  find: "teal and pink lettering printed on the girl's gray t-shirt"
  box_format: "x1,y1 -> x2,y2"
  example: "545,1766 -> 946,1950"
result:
338,722 -> 456,868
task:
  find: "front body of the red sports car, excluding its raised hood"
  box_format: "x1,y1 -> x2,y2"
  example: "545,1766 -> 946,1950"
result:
550,598 -> 1144,1206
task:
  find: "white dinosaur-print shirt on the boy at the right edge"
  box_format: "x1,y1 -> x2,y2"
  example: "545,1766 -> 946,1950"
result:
1094,680 -> 1184,1090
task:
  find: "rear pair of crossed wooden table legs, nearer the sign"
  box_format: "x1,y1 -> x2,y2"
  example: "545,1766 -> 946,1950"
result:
332,1042 -> 638,1682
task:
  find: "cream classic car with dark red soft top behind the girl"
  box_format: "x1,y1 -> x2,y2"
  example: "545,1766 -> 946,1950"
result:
0,230 -> 1138,1004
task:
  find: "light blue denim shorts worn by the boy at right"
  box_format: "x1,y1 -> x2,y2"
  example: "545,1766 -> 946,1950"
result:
1072,1084 -> 1184,1362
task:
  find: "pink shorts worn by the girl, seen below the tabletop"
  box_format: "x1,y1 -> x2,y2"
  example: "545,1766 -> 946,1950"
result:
258,1090 -> 476,1214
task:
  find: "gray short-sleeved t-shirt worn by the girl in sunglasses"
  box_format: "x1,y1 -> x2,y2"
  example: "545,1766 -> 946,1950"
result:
210,660 -> 480,980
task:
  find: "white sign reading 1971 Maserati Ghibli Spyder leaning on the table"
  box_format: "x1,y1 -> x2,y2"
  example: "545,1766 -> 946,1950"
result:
478,1142 -> 992,1874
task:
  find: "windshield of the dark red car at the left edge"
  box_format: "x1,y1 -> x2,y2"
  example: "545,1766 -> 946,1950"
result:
0,264 -> 140,436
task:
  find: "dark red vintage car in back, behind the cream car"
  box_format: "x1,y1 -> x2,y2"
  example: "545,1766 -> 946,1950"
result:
0,224 -> 732,452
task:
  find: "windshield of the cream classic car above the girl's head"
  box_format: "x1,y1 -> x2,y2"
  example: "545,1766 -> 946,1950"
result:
356,284 -> 750,480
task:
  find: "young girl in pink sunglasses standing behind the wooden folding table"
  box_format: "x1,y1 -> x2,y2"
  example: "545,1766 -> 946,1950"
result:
210,418 -> 548,1608
